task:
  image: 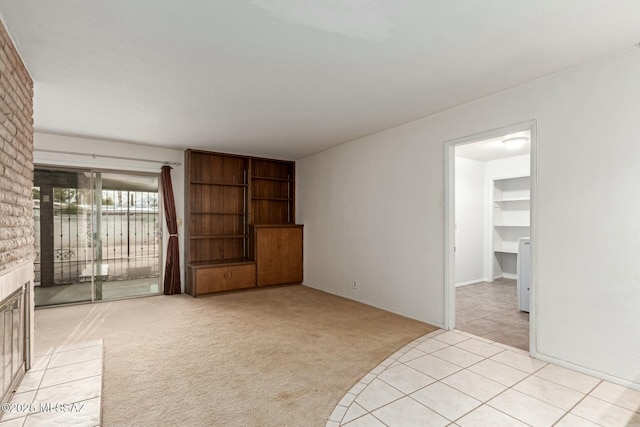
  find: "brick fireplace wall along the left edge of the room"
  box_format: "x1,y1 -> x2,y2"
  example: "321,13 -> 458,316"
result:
0,19 -> 34,401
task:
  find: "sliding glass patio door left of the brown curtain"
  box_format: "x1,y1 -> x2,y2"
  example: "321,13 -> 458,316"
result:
33,166 -> 162,307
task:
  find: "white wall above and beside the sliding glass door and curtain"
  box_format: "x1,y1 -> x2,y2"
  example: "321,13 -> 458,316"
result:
33,133 -> 185,291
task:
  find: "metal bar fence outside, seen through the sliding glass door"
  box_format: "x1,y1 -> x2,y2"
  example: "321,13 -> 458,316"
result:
33,188 -> 162,285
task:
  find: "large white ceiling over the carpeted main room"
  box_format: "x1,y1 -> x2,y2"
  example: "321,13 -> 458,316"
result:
0,0 -> 640,159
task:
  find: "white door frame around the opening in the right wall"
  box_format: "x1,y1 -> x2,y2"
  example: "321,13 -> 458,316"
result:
444,120 -> 538,356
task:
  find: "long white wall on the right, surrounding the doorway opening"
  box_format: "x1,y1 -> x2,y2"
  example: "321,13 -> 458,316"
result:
297,48 -> 640,385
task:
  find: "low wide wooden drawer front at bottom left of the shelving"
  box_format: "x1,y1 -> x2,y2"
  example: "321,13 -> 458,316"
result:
193,264 -> 256,296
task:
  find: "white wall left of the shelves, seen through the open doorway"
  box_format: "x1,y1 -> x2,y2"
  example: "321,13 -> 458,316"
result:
455,156 -> 484,286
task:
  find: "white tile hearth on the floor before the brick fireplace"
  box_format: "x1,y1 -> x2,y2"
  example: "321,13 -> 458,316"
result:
0,340 -> 103,427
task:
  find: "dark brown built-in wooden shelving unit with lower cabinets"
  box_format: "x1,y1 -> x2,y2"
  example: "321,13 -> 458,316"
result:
185,150 -> 302,296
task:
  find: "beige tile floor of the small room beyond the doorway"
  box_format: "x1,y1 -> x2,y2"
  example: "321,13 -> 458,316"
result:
456,279 -> 529,350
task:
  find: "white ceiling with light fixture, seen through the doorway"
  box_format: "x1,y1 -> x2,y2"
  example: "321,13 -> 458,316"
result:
455,131 -> 531,162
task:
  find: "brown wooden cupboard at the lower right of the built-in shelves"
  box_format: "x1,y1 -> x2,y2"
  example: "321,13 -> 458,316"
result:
250,225 -> 302,286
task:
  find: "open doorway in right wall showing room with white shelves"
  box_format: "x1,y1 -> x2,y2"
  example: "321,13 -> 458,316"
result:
445,122 -> 535,351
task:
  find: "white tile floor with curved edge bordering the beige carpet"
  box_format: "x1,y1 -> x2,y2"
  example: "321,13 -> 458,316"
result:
330,330 -> 640,427
